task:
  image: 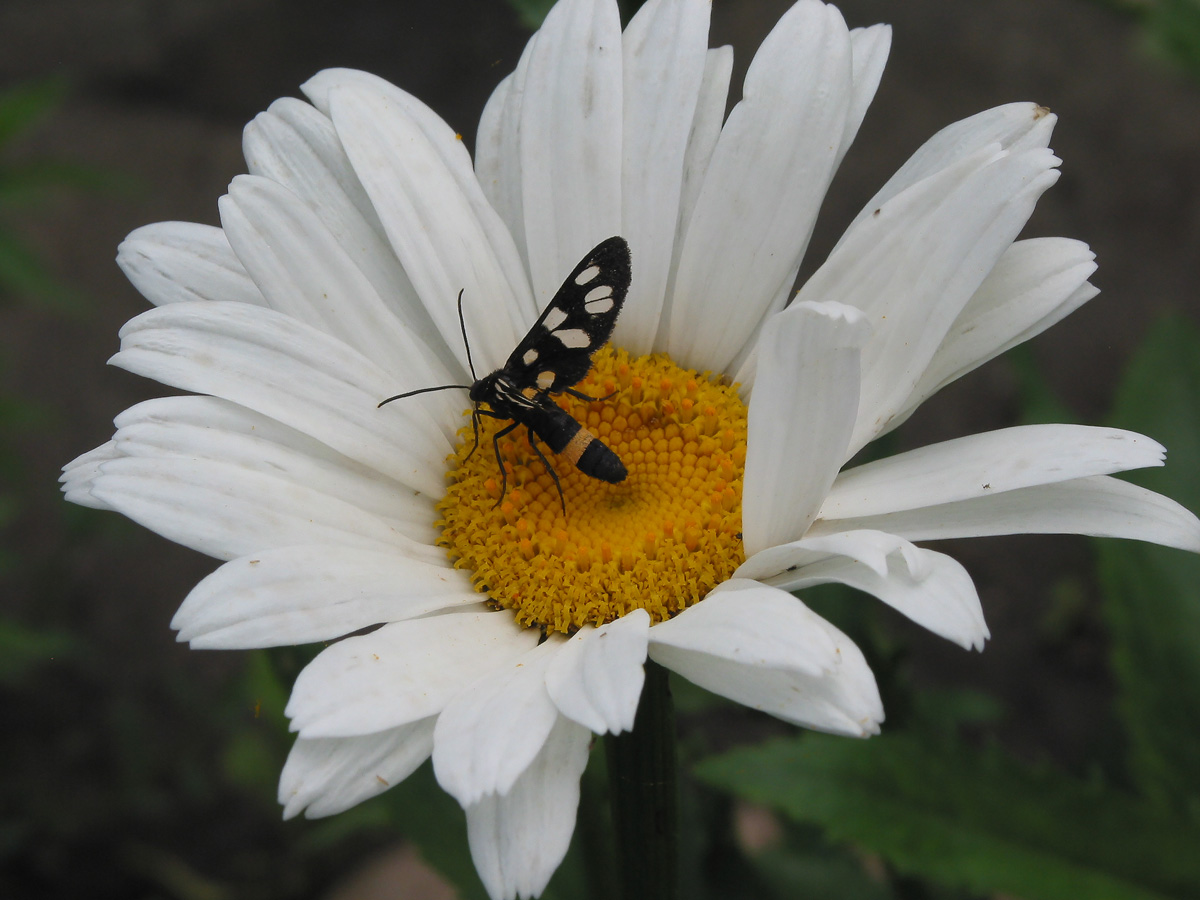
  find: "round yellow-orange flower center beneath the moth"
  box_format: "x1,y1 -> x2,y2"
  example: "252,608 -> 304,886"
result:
438,347 -> 746,634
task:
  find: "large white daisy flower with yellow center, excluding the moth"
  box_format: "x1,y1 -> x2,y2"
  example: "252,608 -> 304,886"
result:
62,0 -> 1200,898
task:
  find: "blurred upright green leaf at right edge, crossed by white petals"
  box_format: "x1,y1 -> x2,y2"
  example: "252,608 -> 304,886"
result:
1097,316 -> 1200,821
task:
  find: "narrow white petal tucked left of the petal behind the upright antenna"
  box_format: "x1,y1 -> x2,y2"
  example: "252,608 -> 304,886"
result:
242,97 -> 464,377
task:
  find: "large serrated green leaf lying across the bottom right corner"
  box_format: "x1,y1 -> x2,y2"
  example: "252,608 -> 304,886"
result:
696,733 -> 1200,900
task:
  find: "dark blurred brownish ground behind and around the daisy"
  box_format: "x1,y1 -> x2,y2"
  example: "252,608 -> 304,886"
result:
0,0 -> 1200,900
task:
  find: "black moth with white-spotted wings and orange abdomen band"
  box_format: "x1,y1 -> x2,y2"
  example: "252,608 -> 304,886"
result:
379,238 -> 630,512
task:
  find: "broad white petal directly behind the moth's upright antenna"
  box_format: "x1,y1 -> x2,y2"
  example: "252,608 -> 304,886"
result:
329,85 -> 533,374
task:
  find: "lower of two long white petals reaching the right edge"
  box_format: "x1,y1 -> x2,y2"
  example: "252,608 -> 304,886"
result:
809,475 -> 1200,553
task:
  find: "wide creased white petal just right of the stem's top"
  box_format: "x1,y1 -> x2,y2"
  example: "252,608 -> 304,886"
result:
649,580 -> 883,737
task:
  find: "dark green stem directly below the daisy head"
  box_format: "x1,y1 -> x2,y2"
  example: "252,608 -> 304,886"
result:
605,660 -> 679,900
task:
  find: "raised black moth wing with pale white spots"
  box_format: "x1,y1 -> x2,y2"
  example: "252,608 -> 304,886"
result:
504,238 -> 630,394
